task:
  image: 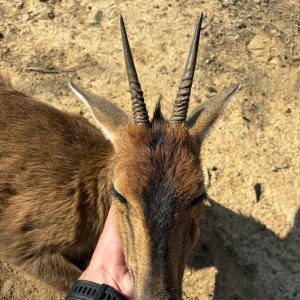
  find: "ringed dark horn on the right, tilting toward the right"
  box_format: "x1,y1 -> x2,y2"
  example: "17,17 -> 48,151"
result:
170,13 -> 203,125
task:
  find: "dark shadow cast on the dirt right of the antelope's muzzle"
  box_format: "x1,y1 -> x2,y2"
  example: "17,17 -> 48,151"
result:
188,199 -> 300,300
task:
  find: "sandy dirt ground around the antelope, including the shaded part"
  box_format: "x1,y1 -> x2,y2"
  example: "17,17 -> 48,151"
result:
0,0 -> 300,300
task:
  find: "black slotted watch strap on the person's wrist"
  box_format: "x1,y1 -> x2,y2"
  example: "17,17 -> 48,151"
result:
66,280 -> 126,300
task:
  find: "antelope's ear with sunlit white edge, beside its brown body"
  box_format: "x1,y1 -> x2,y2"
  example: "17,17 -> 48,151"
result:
69,82 -> 129,144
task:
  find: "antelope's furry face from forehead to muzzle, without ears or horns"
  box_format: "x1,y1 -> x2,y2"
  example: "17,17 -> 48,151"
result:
113,120 -> 204,299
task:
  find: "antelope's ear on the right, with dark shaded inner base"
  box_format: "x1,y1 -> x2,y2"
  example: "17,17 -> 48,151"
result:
187,84 -> 239,146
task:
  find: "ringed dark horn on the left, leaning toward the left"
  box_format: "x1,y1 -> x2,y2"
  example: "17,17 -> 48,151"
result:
120,16 -> 150,126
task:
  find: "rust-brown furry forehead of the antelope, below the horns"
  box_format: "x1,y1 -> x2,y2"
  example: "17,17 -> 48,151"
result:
115,116 -> 203,201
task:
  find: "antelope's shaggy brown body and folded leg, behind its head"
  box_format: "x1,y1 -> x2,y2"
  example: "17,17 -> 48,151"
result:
0,80 -> 112,289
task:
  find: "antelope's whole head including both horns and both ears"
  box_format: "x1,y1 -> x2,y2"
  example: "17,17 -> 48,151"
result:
71,15 -> 238,299
